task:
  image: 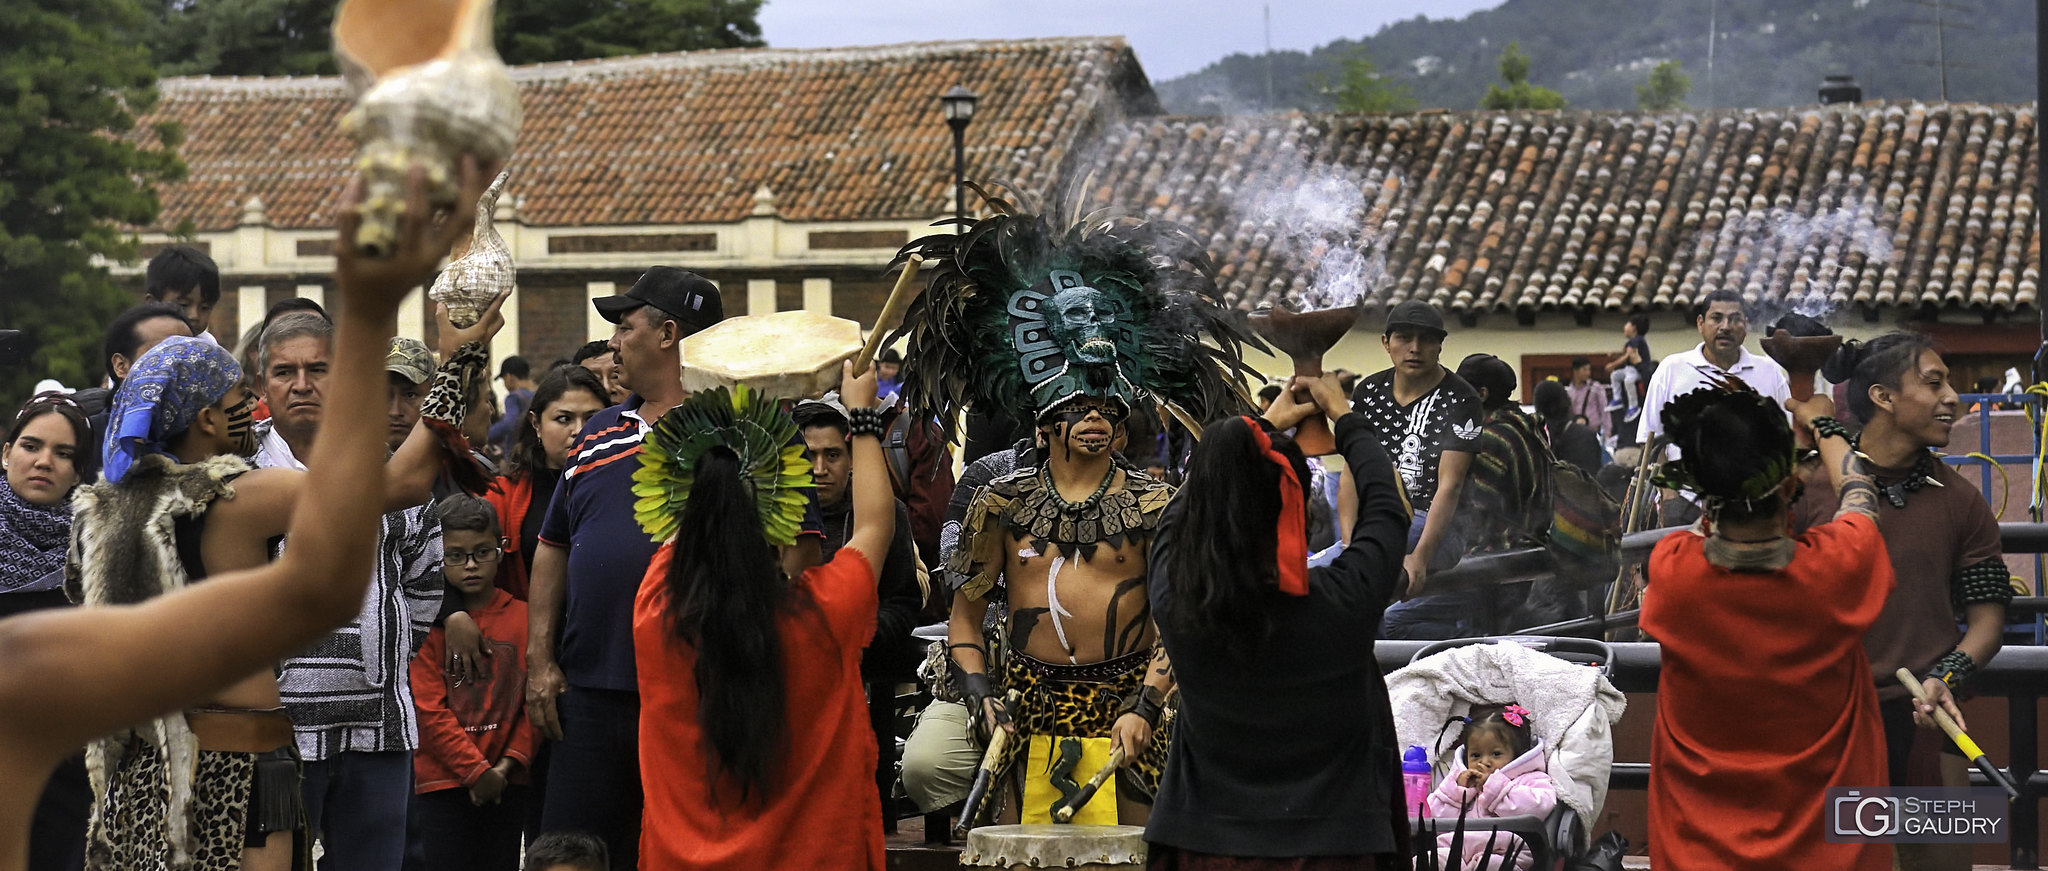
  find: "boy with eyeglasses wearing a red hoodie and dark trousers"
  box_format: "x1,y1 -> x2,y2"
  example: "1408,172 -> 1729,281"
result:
412,496 -> 539,871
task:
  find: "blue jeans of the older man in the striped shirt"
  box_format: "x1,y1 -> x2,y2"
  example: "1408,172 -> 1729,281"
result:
301,750 -> 412,871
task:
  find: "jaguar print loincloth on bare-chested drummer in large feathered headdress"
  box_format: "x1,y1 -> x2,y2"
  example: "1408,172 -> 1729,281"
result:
997,648 -> 1174,803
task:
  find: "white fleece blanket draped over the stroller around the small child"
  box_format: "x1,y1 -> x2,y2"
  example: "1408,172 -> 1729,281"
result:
1386,641 -> 1628,848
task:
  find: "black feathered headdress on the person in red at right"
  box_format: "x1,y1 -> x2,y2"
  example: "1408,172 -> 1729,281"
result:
1653,373 -> 1798,502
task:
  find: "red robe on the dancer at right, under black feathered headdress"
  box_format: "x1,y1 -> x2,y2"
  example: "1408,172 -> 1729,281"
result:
1640,514 -> 1892,871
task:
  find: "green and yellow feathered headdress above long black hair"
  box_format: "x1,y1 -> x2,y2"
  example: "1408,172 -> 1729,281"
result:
633,385 -> 813,545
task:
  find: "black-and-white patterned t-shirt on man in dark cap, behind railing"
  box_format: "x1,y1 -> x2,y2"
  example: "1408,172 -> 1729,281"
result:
1352,369 -> 1487,510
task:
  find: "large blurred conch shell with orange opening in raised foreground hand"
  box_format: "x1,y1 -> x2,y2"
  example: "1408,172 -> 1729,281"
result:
334,0 -> 520,256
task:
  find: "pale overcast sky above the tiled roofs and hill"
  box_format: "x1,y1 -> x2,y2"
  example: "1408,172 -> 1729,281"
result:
760,0 -> 1501,82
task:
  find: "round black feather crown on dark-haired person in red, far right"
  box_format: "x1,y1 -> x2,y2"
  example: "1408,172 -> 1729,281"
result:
1653,373 -> 1798,502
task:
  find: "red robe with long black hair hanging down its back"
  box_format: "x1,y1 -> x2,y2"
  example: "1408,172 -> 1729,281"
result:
633,543 -> 876,871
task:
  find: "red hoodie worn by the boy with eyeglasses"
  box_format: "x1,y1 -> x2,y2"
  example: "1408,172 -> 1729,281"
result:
412,590 -> 541,793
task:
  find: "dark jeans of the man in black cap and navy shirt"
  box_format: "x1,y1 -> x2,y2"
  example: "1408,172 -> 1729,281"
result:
541,687 -> 641,869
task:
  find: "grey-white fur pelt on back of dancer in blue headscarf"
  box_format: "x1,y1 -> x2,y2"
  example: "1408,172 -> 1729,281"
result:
63,455 -> 250,867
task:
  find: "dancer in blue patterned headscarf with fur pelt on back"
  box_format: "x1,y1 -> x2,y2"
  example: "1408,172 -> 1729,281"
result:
68,301 -> 489,871
